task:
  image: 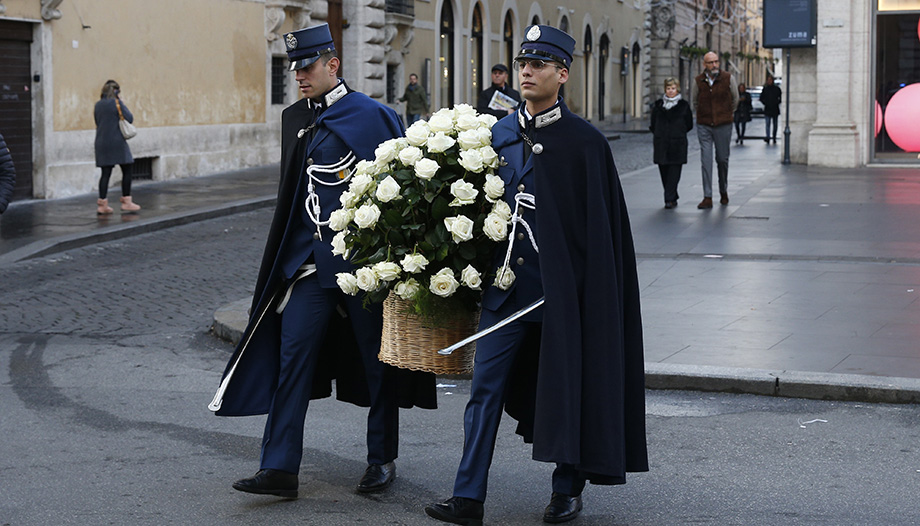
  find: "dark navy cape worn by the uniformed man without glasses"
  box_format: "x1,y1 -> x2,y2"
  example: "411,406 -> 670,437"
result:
216,87 -> 437,416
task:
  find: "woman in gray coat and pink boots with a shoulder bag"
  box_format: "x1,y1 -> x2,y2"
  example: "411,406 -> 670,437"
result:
93,80 -> 141,215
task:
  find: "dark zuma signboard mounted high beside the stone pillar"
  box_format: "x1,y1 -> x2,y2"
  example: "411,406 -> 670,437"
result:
763,0 -> 818,48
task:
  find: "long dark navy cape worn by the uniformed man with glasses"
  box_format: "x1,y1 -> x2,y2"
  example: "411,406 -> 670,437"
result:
492,101 -> 648,484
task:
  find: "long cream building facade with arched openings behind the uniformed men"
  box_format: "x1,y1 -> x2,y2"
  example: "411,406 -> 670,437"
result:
0,0 -> 648,203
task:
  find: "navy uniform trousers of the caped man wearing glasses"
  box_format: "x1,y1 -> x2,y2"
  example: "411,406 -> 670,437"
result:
454,309 -> 585,502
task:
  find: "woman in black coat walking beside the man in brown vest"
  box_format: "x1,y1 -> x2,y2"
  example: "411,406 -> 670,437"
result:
649,77 -> 693,209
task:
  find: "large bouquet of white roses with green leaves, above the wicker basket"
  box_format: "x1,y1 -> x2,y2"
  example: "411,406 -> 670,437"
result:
329,104 -> 511,316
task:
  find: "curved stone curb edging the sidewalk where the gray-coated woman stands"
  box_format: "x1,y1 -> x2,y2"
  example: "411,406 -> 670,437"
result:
0,196 -> 277,266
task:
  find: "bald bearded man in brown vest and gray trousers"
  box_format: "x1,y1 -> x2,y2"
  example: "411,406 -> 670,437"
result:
690,51 -> 738,209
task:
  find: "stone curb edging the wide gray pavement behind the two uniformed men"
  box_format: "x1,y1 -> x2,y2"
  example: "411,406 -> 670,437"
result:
212,298 -> 920,404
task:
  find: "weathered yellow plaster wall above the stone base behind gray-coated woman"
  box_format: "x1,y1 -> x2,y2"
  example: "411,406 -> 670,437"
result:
52,0 -> 267,131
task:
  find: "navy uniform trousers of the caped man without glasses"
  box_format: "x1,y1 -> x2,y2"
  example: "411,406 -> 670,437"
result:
261,274 -> 399,473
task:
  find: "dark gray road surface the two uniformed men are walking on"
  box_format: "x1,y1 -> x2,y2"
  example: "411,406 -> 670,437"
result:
0,207 -> 920,526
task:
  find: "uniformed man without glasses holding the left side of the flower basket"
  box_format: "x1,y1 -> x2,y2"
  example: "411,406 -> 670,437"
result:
210,24 -> 435,504
